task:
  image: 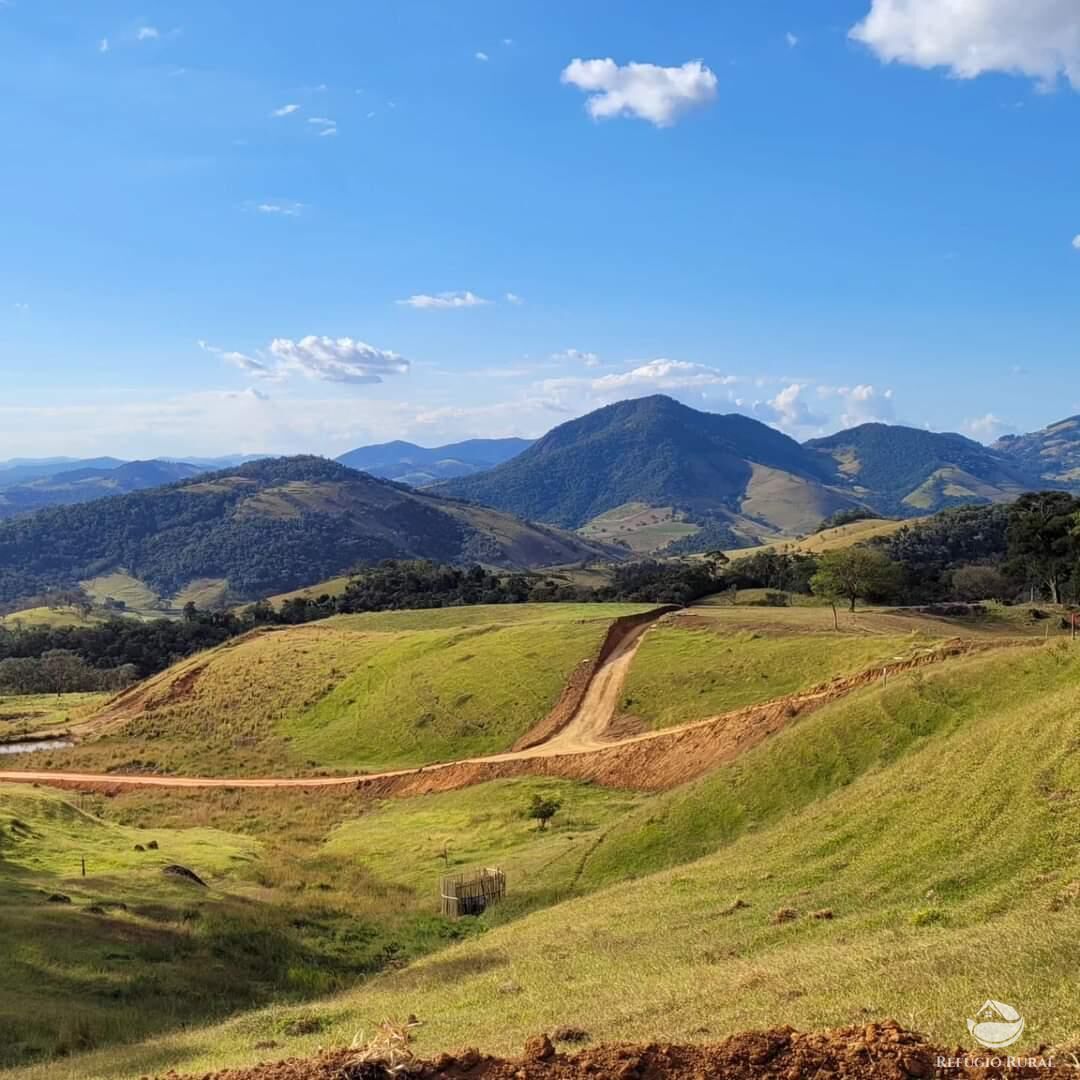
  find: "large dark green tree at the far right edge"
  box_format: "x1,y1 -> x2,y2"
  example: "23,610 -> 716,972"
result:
1005,491 -> 1080,604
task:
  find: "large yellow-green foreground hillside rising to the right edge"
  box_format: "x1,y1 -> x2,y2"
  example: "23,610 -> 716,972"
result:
33,647 -> 1080,1080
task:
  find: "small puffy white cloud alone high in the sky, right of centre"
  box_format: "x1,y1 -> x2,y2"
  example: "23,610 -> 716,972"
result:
562,58 -> 717,127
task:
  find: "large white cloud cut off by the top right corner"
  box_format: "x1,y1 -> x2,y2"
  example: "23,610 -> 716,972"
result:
850,0 -> 1080,90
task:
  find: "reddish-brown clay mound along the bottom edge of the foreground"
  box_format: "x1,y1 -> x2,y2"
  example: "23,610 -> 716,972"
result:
157,1021 -> 1078,1080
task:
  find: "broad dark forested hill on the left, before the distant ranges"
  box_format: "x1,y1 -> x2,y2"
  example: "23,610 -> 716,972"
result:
0,457 -> 612,602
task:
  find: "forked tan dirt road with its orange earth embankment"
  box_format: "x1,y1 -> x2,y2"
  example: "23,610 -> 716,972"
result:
0,623 -> 1041,795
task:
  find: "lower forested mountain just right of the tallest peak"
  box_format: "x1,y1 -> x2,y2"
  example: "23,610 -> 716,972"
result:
805,423 -> 1036,514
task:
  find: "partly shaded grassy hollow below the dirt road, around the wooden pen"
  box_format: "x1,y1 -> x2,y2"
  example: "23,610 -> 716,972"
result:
0,781 -> 640,1076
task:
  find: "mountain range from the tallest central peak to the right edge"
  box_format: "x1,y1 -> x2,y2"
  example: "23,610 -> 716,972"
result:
434,395 -> 1080,543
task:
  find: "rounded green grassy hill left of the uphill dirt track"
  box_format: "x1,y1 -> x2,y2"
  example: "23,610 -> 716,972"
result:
17,604 -> 647,775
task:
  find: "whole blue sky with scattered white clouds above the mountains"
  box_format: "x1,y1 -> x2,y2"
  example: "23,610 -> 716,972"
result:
0,0 -> 1080,457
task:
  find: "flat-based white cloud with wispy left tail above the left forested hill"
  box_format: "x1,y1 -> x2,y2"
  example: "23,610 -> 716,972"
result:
198,334 -> 409,384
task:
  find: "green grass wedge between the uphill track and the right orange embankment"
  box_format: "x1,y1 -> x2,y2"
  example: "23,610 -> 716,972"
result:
621,620 -> 941,728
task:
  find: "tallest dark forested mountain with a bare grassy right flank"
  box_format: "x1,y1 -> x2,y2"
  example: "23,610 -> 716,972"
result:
435,395 -> 858,540
